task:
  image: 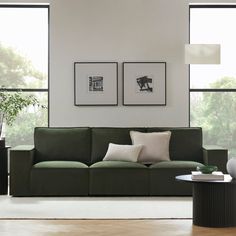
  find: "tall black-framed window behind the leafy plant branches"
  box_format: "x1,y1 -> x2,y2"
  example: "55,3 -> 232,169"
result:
0,5 -> 49,146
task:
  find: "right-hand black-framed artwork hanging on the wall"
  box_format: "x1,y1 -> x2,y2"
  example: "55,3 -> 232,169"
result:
123,62 -> 166,106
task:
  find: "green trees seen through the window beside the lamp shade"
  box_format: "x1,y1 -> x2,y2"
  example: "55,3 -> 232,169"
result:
191,77 -> 236,157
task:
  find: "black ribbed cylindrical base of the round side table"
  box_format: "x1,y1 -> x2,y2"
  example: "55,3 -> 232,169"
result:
193,182 -> 236,227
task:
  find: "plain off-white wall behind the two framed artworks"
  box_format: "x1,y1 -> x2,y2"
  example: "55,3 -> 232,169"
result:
0,0 -> 235,126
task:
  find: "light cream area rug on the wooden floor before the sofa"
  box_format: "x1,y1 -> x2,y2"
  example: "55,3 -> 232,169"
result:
0,195 -> 192,219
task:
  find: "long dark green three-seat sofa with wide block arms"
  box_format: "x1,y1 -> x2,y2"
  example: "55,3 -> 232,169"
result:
10,127 -> 227,196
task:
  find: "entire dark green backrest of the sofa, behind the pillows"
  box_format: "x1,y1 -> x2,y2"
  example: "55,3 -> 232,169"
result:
34,127 -> 203,165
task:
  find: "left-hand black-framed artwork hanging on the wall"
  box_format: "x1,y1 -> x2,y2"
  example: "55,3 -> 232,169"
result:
74,62 -> 118,106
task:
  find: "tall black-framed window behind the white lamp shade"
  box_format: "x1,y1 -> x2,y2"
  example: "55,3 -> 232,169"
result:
190,5 -> 236,157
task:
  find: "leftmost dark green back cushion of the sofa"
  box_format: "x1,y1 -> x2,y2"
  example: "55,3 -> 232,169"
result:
34,127 -> 91,164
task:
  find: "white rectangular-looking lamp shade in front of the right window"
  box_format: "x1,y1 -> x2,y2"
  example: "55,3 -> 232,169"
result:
185,44 -> 220,64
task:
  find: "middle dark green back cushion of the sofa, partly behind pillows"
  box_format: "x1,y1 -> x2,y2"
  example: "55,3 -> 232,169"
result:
91,128 -> 146,163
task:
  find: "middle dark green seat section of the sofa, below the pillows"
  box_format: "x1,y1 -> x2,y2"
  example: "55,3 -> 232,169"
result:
89,161 -> 149,196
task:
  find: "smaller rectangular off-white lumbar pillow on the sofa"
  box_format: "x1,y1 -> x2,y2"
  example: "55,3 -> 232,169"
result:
103,143 -> 143,162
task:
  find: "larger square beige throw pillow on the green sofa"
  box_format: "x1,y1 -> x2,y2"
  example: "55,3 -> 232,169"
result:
130,131 -> 171,164
